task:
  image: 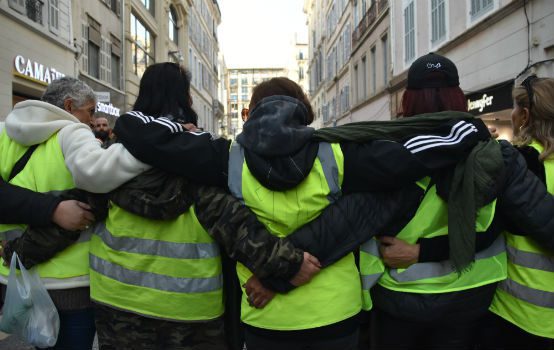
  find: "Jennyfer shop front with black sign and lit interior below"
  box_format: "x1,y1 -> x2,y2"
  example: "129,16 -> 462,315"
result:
466,80 -> 514,140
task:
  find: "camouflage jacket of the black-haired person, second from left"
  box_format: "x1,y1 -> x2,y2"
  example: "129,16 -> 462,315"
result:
3,169 -> 303,280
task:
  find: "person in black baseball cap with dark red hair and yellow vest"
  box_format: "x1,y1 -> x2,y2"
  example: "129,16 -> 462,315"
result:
360,54 -> 553,349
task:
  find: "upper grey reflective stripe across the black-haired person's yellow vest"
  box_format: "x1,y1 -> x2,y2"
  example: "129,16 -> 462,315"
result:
96,223 -> 219,259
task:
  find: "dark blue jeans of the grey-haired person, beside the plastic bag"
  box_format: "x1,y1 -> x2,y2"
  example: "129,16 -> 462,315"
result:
38,308 -> 96,350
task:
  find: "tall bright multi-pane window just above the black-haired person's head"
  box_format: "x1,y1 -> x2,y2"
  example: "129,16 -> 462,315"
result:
131,13 -> 154,77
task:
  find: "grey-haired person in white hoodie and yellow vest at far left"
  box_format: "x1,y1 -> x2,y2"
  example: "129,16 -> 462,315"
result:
0,77 -> 150,349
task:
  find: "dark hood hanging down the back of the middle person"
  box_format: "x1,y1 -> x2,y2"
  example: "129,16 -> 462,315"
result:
237,95 -> 318,191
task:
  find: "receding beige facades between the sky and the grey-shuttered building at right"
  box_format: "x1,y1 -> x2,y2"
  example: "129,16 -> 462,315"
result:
304,0 -> 391,128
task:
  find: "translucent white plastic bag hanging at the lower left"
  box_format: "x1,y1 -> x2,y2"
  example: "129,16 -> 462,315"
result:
0,253 -> 60,348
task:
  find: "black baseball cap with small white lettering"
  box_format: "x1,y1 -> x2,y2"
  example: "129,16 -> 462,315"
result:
408,52 -> 460,89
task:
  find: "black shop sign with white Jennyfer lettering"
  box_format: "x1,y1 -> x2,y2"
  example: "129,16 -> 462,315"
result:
466,80 -> 514,115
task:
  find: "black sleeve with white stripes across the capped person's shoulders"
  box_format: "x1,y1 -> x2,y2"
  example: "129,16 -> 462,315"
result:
341,119 -> 490,193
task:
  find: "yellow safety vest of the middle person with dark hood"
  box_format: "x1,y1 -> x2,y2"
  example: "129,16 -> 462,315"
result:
229,143 -> 361,330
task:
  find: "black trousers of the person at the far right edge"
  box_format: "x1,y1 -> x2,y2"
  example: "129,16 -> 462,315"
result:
476,312 -> 554,350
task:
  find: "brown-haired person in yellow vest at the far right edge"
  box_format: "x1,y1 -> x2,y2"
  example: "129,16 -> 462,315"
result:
483,75 -> 554,349
